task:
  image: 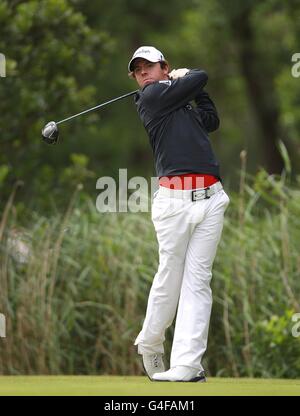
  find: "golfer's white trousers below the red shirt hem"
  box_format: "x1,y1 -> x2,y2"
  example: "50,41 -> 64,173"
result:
134,188 -> 230,370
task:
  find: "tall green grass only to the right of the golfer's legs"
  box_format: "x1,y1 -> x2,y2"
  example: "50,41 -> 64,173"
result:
207,152 -> 300,378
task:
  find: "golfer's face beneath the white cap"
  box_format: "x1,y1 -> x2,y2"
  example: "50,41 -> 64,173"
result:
133,59 -> 169,88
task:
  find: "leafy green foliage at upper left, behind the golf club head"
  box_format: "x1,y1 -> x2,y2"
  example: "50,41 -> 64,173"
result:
0,0 -> 109,208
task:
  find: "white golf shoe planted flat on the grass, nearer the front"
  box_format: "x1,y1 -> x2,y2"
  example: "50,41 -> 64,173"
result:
152,365 -> 206,383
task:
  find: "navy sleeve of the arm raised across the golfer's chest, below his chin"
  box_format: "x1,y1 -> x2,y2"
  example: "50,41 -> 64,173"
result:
143,69 -> 208,113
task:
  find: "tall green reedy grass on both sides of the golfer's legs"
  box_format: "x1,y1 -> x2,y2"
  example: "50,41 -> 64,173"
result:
0,157 -> 300,378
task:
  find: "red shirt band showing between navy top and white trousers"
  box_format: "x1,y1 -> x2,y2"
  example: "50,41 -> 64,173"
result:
159,173 -> 219,189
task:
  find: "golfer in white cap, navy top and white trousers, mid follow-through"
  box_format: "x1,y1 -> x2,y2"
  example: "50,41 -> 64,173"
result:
128,46 -> 229,382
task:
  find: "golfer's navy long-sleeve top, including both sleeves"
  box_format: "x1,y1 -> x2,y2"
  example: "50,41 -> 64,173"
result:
135,69 -> 221,179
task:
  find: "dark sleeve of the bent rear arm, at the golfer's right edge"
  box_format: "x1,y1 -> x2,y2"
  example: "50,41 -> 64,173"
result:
195,90 -> 220,133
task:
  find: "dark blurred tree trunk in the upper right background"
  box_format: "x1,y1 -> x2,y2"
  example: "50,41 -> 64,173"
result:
218,0 -> 293,173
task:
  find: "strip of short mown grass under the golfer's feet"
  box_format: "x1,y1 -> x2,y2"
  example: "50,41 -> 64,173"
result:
0,376 -> 300,396
